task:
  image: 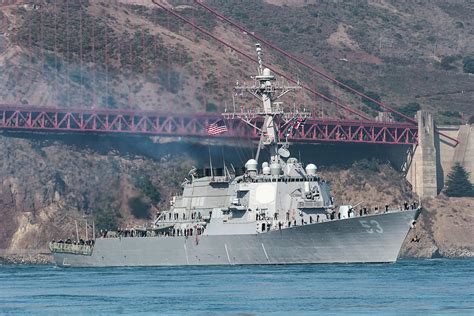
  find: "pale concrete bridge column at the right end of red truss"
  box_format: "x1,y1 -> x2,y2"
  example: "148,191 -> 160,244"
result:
406,111 -> 444,198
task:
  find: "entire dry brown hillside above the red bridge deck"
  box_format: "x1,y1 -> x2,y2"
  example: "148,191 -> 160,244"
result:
0,0 -> 474,123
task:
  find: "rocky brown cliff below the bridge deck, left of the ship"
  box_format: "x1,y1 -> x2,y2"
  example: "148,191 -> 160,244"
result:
0,136 -> 192,254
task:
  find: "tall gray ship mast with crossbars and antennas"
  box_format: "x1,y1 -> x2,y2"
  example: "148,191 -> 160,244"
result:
224,44 -> 307,163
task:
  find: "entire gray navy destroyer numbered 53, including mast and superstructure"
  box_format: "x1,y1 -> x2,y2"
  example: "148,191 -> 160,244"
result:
49,44 -> 420,267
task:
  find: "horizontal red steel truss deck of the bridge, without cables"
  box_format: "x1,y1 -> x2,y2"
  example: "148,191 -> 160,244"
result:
0,105 -> 418,145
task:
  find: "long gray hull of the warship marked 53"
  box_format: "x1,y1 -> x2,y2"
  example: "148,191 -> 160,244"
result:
53,210 -> 419,267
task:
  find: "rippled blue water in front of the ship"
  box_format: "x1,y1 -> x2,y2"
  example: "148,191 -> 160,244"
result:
0,259 -> 474,315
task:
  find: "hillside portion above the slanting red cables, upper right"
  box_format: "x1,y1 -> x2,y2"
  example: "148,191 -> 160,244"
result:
210,0 -> 474,123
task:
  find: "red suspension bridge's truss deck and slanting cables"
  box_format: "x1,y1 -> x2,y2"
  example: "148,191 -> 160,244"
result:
0,0 -> 456,145
